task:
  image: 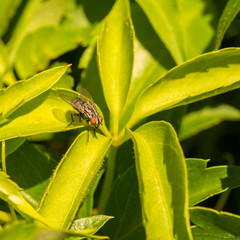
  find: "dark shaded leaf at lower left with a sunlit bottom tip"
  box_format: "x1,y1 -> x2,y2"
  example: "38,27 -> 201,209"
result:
6,140 -> 56,208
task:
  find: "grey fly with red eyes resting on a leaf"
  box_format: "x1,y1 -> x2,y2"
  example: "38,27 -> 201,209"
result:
59,88 -> 103,141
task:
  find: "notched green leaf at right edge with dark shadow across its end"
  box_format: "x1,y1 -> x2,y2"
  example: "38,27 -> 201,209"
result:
186,159 -> 240,206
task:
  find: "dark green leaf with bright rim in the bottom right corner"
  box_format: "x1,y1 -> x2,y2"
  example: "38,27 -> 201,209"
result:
190,207 -> 240,240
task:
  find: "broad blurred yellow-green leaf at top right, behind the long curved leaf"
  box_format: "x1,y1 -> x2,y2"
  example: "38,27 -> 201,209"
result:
137,0 -> 214,64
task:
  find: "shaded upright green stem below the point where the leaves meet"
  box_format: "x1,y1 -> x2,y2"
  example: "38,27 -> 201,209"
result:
98,146 -> 117,213
